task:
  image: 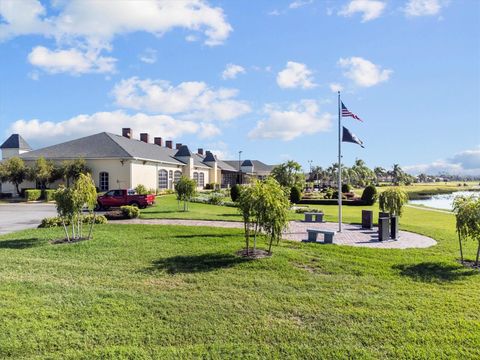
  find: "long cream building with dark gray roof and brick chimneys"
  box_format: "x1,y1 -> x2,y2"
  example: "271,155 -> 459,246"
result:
0,128 -> 274,193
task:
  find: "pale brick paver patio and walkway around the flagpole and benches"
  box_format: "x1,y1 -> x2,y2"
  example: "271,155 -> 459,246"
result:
115,219 -> 437,249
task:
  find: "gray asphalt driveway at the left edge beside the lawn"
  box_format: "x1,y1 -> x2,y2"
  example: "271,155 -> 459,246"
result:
0,203 -> 57,235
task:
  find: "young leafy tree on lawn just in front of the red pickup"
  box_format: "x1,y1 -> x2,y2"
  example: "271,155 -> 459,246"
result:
55,174 -> 97,241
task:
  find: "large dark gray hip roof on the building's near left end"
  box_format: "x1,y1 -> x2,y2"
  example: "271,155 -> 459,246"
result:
21,132 -> 182,165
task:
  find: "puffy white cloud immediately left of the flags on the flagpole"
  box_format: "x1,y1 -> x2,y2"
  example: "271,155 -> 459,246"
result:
248,100 -> 333,141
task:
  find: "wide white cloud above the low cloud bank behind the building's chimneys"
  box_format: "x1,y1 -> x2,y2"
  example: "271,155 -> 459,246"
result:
112,77 -> 251,121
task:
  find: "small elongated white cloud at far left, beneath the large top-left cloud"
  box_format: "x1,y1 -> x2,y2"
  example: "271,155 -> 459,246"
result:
28,46 -> 116,75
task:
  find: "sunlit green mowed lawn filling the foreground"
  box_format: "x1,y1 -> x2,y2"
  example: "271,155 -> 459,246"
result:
0,204 -> 480,359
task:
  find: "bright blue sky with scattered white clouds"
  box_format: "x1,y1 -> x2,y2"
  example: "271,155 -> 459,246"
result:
0,0 -> 480,175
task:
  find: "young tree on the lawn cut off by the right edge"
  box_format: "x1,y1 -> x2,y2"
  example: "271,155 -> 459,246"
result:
453,196 -> 480,266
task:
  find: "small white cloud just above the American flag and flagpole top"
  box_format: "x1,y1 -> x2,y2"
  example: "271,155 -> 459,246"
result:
338,56 -> 393,87
